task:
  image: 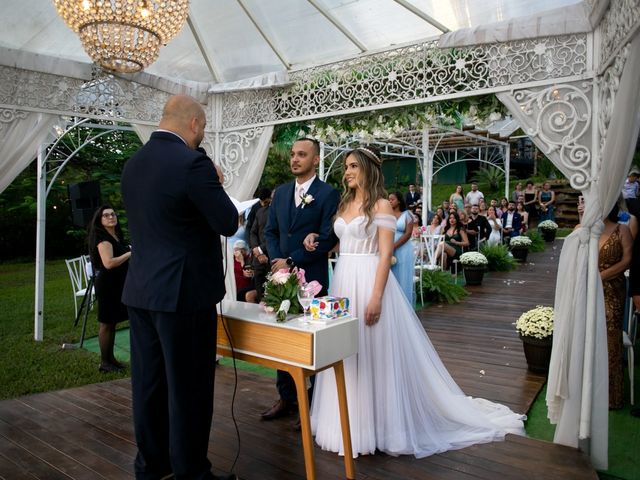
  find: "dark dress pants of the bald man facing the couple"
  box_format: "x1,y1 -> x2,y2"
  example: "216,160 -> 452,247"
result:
129,307 -> 217,480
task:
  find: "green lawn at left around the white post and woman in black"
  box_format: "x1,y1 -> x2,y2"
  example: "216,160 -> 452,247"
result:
0,260 -> 128,400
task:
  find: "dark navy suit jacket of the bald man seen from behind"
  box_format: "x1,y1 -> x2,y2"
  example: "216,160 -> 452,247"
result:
121,132 -> 238,312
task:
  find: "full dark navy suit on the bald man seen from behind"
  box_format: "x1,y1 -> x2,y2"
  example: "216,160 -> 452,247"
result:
122,132 -> 238,480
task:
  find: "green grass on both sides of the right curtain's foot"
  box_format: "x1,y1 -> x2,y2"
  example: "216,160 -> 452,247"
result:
525,365 -> 640,480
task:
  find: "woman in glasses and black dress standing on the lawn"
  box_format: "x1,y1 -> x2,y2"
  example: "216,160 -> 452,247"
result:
87,205 -> 131,372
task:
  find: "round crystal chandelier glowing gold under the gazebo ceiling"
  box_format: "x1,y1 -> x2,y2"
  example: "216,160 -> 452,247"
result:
53,0 -> 189,73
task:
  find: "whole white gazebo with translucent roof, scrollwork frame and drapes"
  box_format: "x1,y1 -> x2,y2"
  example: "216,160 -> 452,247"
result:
0,0 -> 640,469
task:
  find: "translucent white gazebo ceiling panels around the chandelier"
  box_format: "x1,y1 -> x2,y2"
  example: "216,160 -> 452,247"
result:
0,0 -> 580,84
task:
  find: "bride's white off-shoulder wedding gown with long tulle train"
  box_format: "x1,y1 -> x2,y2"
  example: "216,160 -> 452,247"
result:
311,214 -> 525,458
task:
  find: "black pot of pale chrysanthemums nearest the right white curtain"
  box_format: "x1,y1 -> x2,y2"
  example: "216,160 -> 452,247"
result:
516,305 -> 553,373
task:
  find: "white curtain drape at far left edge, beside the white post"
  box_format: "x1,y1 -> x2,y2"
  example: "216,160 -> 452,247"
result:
0,108 -> 58,193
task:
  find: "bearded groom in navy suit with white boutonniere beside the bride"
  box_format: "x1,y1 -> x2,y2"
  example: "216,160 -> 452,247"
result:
262,138 -> 340,420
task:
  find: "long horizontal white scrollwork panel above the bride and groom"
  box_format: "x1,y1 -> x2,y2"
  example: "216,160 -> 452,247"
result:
222,34 -> 588,130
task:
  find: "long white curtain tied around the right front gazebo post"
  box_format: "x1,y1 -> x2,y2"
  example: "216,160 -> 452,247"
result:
498,31 -> 640,469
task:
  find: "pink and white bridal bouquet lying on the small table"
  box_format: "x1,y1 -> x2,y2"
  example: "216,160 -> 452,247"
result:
261,268 -> 322,322
